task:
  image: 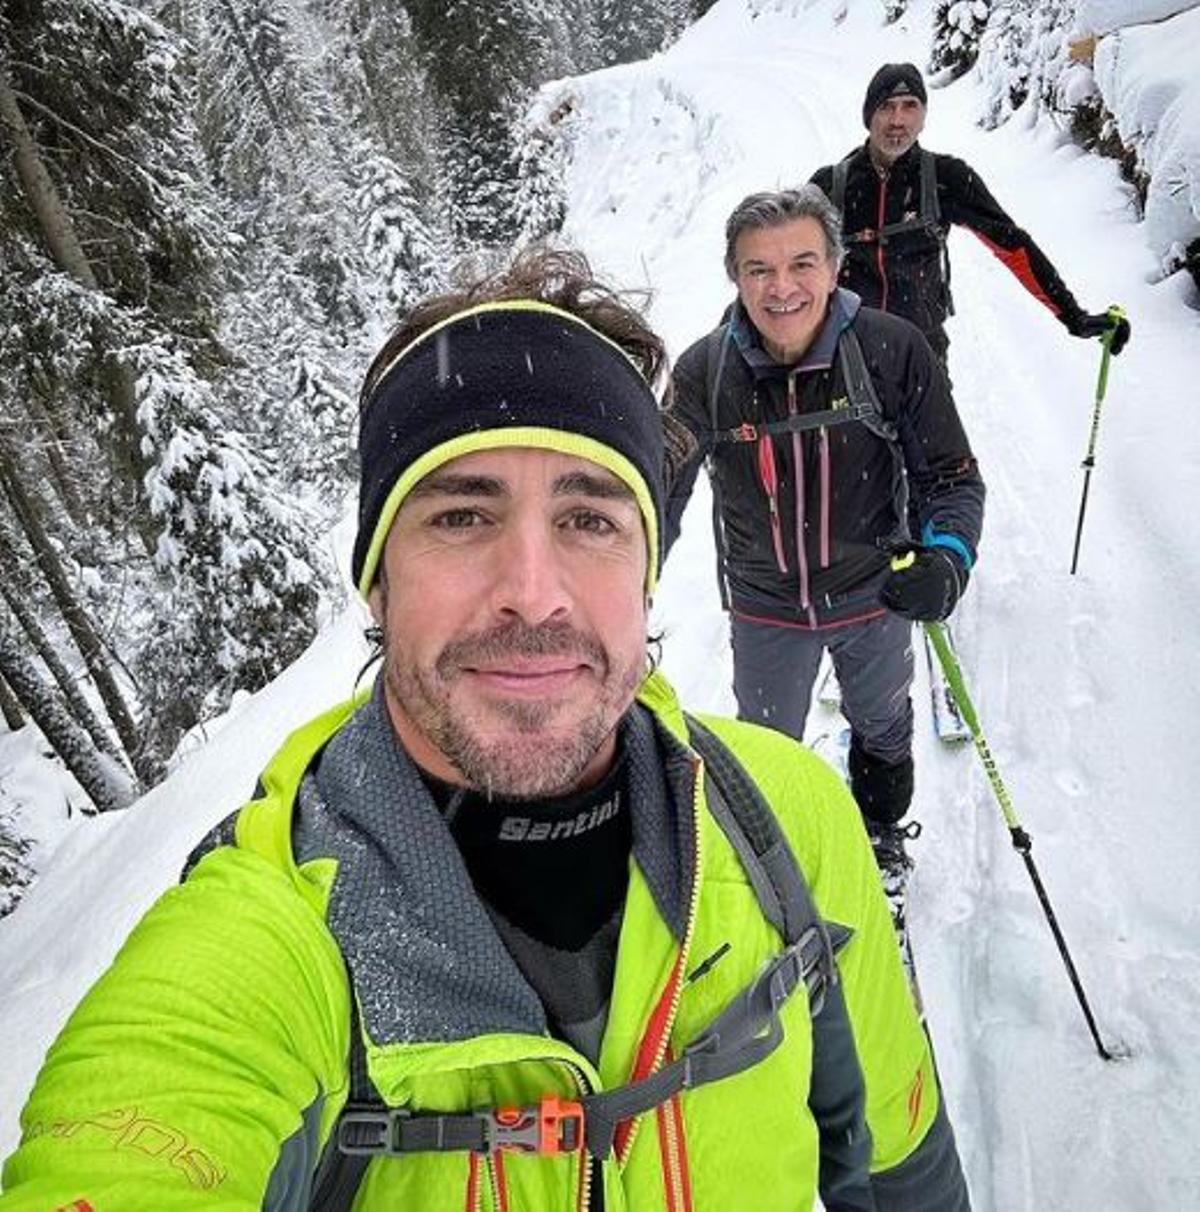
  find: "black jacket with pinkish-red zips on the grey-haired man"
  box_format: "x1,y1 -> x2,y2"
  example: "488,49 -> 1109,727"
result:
665,290 -> 984,628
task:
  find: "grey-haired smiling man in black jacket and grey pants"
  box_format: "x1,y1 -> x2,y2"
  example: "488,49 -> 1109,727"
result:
667,185 -> 984,882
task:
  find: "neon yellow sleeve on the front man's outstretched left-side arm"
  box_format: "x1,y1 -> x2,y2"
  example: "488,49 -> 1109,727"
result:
0,847 -> 350,1212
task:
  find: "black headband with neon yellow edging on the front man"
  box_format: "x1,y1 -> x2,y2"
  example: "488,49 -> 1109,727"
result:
352,299 -> 665,598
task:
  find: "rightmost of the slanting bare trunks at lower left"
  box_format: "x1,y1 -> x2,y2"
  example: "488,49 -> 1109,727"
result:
0,438 -> 161,787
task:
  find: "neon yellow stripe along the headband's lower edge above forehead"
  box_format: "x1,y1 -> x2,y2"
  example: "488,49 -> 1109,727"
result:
359,429 -> 658,598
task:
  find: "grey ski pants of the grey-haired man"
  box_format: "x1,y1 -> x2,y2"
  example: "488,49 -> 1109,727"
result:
730,611 -> 913,762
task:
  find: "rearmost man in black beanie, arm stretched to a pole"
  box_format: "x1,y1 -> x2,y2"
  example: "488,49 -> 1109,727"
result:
811,63 -> 1130,367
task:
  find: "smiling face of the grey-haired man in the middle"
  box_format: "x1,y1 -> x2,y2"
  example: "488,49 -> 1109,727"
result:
735,216 -> 838,362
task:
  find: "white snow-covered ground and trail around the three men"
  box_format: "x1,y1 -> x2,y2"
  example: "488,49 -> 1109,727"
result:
0,0 -> 1200,1212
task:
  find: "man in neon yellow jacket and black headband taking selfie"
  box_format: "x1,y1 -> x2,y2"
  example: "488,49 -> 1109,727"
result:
0,253 -> 968,1212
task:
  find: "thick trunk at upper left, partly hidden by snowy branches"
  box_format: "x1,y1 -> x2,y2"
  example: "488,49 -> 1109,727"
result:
0,61 -> 156,545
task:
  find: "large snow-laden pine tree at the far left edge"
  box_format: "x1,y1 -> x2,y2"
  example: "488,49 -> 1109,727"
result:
0,0 -> 329,777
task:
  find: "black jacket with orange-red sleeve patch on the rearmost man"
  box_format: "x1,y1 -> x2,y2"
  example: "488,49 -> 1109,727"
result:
811,143 -> 1082,333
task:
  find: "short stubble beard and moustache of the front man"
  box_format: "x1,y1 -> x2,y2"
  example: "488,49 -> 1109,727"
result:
384,622 -> 645,800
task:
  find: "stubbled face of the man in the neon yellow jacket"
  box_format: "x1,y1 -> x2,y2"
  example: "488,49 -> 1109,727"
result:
371,447 -> 647,799
